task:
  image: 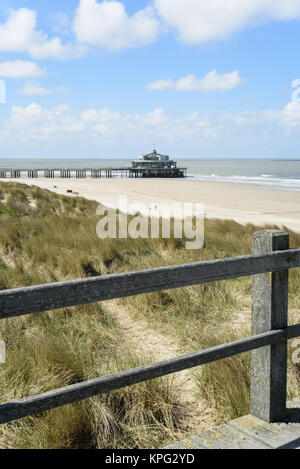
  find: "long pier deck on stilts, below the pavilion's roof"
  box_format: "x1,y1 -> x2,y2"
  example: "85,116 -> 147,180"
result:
0,167 -> 187,179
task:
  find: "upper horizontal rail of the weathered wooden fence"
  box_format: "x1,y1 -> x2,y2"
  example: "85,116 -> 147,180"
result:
0,249 -> 300,319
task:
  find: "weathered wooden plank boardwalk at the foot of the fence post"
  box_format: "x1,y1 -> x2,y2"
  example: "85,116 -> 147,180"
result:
168,399 -> 300,449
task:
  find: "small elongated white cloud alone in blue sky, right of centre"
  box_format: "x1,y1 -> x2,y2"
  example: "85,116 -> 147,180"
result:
148,70 -> 246,91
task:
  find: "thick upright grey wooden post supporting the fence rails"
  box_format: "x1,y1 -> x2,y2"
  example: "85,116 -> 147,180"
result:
251,230 -> 289,423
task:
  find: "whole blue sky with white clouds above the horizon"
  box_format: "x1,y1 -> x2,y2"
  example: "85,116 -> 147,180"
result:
0,0 -> 300,159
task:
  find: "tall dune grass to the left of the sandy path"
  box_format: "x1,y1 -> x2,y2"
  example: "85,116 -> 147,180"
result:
0,183 -> 184,448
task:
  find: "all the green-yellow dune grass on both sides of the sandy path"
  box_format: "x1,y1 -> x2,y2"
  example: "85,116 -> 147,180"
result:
0,183 -> 300,448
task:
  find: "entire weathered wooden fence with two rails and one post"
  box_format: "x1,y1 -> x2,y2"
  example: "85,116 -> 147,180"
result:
0,231 -> 300,423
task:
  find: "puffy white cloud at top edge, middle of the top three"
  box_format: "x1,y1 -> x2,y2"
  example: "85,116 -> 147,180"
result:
74,0 -> 159,50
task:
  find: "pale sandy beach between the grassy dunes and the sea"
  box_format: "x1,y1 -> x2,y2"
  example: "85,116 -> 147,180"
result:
2,178 -> 300,232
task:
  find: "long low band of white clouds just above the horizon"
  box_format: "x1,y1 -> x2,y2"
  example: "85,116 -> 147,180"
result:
0,93 -> 300,145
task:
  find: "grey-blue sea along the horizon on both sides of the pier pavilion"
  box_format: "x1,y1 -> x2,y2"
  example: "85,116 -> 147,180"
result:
0,158 -> 300,191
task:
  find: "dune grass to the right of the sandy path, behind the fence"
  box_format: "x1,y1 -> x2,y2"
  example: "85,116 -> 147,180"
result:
124,220 -> 300,424
